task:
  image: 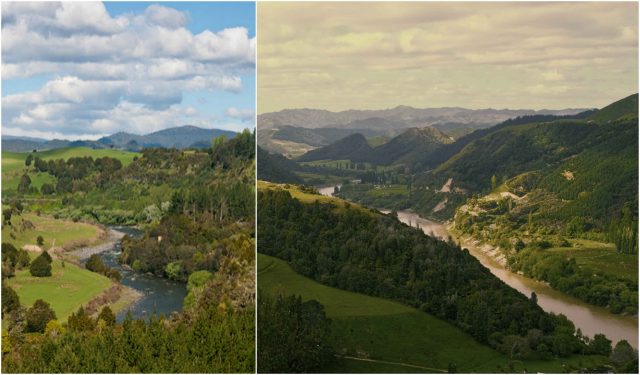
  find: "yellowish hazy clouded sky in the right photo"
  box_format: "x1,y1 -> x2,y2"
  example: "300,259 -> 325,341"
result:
258,2 -> 638,113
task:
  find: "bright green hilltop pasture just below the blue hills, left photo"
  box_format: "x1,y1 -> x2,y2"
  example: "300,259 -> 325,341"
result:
2,147 -> 138,191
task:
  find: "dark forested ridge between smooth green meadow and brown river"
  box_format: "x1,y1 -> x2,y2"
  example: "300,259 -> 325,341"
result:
258,186 -> 616,358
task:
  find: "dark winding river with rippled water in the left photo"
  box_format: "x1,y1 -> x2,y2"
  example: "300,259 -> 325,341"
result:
74,227 -> 187,322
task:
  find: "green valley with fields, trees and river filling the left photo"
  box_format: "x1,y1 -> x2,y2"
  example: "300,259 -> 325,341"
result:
2,130 -> 255,372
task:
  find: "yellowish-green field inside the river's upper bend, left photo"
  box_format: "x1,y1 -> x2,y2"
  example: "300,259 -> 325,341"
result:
2,213 -> 102,249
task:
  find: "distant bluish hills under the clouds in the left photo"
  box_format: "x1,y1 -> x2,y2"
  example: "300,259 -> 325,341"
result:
2,125 -> 236,152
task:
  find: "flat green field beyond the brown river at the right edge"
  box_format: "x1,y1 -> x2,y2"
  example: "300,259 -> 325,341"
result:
550,239 -> 638,283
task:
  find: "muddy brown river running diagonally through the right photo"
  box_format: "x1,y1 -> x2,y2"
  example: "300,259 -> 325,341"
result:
318,186 -> 638,348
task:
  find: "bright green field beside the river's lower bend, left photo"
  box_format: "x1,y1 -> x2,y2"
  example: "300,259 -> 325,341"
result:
5,254 -> 112,321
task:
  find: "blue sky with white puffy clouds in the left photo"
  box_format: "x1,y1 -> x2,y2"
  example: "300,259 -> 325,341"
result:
2,2 -> 256,140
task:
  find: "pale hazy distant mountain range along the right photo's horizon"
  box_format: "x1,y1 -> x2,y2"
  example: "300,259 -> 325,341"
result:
258,106 -> 585,154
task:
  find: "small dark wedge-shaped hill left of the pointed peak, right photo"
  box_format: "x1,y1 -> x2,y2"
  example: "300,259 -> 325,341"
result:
298,133 -> 372,162
